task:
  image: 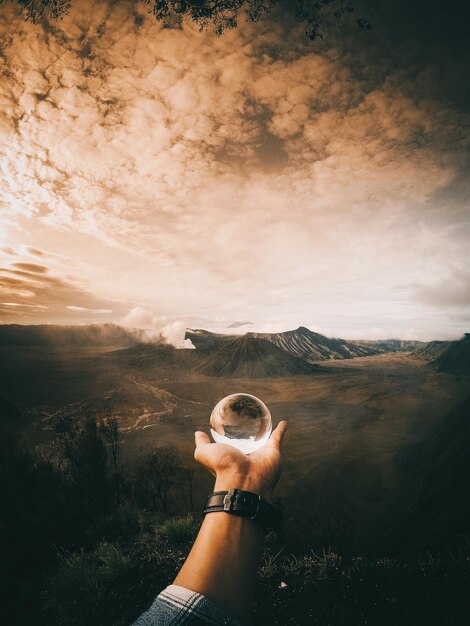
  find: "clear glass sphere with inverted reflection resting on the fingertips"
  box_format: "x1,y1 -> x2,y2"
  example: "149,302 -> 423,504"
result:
210,393 -> 272,454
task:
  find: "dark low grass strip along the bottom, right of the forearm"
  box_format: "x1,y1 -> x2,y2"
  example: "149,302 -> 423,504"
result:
255,553 -> 470,626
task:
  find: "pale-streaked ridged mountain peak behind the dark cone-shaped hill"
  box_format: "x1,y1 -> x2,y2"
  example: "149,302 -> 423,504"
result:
248,326 -> 384,363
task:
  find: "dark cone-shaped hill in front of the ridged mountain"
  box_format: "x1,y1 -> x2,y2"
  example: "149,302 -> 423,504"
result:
196,335 -> 320,378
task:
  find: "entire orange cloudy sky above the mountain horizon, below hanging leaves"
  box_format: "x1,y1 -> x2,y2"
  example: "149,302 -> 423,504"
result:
0,0 -> 470,340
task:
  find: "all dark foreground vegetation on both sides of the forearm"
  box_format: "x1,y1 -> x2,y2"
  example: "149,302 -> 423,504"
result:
0,405 -> 470,626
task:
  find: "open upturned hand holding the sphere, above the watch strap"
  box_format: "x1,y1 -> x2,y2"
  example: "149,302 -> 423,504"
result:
194,421 -> 287,498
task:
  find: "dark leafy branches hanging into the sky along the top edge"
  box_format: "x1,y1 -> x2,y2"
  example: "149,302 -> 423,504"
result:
0,0 -> 371,40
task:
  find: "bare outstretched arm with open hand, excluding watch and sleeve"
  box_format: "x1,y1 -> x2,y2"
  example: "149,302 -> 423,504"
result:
174,421 -> 287,624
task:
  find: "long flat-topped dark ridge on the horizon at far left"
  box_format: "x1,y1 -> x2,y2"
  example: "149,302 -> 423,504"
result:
0,324 -> 142,347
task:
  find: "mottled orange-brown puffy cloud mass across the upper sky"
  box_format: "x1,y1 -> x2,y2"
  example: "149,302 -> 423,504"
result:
3,3 -> 465,258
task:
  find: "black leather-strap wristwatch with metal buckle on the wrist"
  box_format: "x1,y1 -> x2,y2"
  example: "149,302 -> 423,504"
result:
204,489 -> 282,533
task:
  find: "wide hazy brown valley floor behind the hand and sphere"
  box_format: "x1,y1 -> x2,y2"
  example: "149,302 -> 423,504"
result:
0,334 -> 468,552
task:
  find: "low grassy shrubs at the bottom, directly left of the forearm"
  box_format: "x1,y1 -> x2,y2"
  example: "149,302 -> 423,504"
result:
44,533 -> 187,626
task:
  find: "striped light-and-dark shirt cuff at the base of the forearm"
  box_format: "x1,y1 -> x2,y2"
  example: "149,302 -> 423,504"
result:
133,585 -> 240,626
